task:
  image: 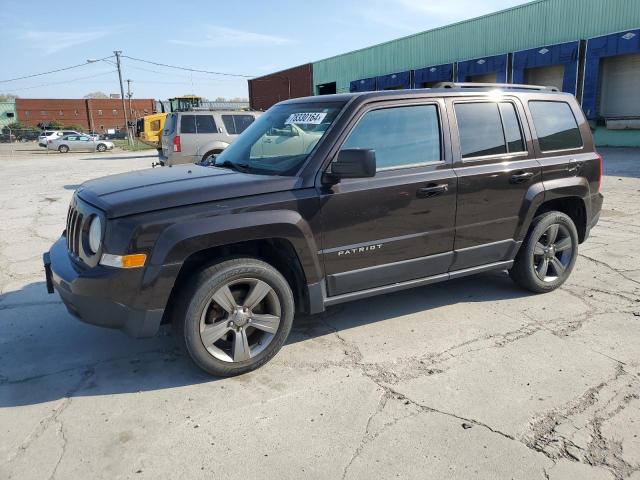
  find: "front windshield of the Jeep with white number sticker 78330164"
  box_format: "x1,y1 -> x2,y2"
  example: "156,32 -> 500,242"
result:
215,102 -> 344,175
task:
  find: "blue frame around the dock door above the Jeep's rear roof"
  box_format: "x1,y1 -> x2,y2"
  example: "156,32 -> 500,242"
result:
513,42 -> 580,95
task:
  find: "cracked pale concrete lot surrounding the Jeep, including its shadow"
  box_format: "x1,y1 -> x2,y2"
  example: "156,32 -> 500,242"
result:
0,145 -> 640,480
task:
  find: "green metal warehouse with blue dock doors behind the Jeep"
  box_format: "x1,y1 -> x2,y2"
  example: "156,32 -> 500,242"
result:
252,0 -> 640,146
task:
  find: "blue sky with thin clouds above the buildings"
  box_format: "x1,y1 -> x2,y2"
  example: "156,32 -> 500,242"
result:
0,0 -> 525,99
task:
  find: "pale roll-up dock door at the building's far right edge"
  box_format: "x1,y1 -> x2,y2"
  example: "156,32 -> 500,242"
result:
599,54 -> 640,118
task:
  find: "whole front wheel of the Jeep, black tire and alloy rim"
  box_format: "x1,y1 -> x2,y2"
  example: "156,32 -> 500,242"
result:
173,258 -> 295,377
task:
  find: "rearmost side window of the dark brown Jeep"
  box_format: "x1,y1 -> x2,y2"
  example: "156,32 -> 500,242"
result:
529,101 -> 582,152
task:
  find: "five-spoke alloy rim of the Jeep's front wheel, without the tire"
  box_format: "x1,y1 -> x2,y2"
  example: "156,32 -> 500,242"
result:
200,278 -> 281,362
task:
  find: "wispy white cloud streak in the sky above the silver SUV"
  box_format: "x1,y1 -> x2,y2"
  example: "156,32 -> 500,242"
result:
169,25 -> 294,48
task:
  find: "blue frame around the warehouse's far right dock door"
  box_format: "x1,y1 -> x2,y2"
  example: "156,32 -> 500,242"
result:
582,29 -> 640,119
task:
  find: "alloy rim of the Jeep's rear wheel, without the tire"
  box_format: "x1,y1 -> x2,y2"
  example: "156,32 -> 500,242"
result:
533,223 -> 574,282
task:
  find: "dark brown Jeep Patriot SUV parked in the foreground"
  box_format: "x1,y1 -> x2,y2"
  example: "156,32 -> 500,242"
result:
44,84 -> 603,375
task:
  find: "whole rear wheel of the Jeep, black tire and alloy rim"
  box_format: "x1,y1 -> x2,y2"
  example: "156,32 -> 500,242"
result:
509,211 -> 578,293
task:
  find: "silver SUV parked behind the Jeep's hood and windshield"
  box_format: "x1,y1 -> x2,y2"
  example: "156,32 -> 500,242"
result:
159,110 -> 262,165
